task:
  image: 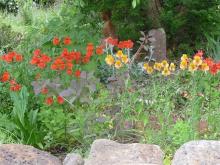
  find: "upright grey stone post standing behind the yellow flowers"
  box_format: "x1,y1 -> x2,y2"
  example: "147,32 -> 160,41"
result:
148,28 -> 167,62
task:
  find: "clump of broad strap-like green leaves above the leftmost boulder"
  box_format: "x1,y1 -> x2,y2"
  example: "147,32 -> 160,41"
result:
11,87 -> 43,148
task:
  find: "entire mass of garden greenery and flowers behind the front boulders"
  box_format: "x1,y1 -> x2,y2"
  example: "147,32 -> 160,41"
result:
0,0 -> 220,164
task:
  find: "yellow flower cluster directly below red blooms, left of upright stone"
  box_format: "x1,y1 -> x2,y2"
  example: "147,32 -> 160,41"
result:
105,50 -> 130,69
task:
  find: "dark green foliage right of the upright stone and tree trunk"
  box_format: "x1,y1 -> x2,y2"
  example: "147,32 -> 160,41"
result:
161,0 -> 220,53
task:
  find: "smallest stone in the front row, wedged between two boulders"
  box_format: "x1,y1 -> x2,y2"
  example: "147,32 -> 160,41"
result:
63,153 -> 84,165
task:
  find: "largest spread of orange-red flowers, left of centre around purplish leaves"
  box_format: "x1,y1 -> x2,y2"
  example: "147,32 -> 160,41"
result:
30,37 -> 104,105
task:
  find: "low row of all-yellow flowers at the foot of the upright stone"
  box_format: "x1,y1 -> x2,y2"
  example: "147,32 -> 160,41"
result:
143,60 -> 176,76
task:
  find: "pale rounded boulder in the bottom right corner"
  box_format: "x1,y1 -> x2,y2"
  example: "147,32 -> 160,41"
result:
172,140 -> 220,165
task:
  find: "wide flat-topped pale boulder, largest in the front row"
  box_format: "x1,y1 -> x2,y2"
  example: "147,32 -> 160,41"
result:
85,139 -> 164,165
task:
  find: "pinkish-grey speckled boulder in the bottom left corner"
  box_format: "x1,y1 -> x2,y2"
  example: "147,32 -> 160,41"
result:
0,144 -> 62,165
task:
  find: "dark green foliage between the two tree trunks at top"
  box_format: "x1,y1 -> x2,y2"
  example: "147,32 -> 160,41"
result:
82,0 -> 151,40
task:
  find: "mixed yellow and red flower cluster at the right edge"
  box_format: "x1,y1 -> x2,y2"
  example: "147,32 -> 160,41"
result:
180,51 -> 220,75
